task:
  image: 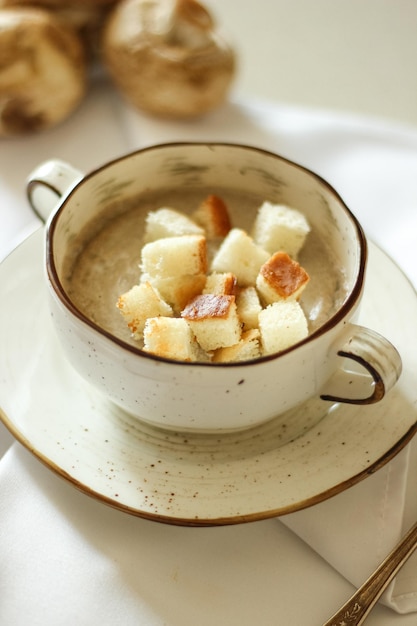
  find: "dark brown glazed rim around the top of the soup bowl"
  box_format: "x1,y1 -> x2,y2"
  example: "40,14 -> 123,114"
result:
46,141 -> 368,368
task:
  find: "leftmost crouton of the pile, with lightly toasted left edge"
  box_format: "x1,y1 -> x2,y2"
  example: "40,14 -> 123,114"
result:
116,282 -> 173,340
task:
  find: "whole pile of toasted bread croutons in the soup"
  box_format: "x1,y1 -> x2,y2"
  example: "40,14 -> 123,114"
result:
117,195 -> 309,363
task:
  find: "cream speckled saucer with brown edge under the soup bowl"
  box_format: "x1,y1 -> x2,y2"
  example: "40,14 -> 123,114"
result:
0,230 -> 417,525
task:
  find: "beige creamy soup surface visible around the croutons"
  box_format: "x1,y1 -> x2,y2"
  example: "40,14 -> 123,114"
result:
64,188 -> 347,347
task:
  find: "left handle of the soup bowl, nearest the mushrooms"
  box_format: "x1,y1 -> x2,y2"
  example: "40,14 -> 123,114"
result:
26,159 -> 84,222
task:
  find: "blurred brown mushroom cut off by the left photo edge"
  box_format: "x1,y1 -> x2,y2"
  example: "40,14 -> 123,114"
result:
0,7 -> 86,136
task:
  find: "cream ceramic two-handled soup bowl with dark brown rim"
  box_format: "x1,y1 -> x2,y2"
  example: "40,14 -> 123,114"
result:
27,143 -> 401,432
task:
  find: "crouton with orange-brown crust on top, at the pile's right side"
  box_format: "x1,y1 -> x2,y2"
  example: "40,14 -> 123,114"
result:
256,252 -> 310,304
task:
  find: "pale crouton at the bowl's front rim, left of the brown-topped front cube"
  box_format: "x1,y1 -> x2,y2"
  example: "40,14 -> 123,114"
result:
143,317 -> 200,361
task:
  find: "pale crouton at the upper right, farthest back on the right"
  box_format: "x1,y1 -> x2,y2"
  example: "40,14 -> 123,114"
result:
251,202 -> 310,259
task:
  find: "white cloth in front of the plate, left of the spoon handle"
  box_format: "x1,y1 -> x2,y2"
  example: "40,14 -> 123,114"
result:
0,444 -> 358,626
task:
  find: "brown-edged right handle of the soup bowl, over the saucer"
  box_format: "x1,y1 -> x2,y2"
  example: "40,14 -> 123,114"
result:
320,324 -> 402,404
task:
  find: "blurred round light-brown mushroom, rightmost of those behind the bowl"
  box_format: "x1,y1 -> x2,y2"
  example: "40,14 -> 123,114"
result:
102,0 -> 235,117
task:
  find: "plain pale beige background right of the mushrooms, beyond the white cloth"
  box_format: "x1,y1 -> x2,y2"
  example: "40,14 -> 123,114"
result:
210,0 -> 417,125
